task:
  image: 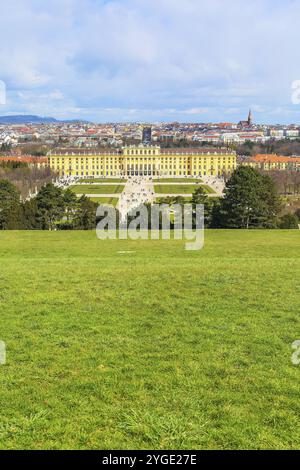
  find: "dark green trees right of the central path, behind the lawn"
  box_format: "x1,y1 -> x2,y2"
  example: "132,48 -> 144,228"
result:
161,166 -> 300,229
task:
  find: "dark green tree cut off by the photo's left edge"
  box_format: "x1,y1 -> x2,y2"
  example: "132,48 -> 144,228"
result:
0,180 -> 21,230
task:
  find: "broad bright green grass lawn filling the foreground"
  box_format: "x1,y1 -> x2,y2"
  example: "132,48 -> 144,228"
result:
0,231 -> 300,449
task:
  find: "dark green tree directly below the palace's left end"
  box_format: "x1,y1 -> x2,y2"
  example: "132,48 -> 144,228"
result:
36,183 -> 65,230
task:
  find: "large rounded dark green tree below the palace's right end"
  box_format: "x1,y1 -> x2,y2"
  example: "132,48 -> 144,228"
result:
219,166 -> 281,229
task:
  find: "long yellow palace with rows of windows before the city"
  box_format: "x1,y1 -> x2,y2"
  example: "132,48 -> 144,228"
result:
48,145 -> 236,178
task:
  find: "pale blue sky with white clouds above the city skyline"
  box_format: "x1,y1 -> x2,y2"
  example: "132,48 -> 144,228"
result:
0,0 -> 300,124
